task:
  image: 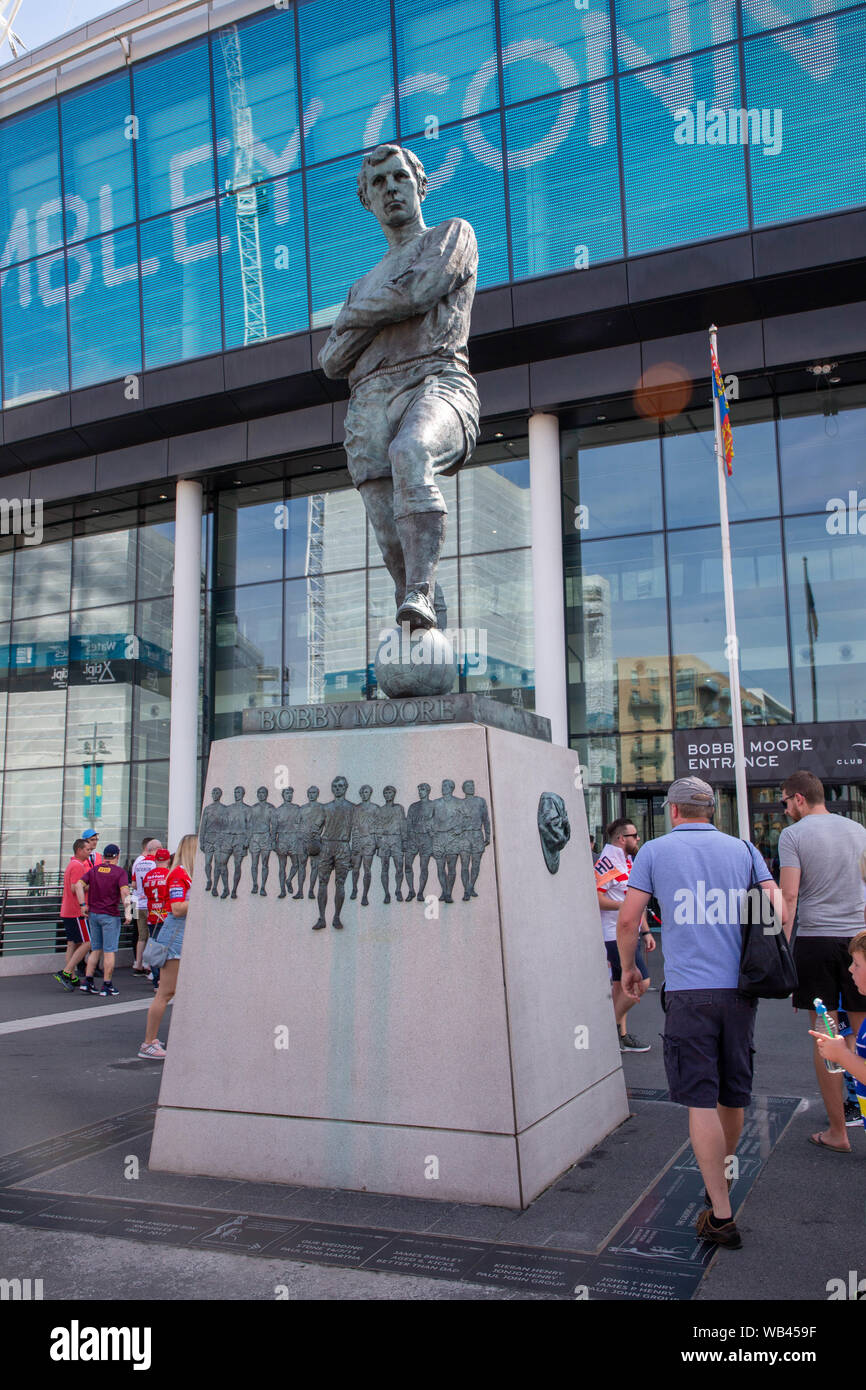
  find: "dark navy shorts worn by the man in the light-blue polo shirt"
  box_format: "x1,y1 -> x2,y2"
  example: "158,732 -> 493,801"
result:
663,990 -> 758,1111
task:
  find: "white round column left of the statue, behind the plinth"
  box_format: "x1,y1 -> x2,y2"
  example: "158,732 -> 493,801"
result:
168,481 -> 202,852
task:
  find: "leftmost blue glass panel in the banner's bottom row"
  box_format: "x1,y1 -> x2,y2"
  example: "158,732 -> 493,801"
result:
0,252 -> 70,406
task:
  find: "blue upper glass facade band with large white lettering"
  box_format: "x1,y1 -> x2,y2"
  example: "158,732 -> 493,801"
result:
0,0 -> 866,407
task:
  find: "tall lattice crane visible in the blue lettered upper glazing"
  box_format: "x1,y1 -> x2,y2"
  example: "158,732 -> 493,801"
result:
216,23 -> 268,343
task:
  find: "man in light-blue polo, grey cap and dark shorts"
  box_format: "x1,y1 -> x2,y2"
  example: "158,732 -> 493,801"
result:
617,777 -> 781,1250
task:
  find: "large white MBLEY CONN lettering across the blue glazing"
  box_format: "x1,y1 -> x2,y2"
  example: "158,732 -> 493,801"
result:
0,0 -> 840,309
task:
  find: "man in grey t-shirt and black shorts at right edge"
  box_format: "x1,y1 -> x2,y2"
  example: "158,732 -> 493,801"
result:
778,771 -> 866,1154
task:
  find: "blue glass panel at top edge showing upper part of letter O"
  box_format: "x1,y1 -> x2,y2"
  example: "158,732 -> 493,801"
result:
499,0 -> 612,106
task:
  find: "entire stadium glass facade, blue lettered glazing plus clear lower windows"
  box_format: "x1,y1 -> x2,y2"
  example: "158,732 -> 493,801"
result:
0,0 -> 866,874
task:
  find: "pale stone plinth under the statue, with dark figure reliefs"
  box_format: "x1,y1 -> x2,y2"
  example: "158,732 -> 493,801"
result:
150,723 -> 628,1208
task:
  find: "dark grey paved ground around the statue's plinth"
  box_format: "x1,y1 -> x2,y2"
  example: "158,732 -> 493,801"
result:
0,952 -> 866,1301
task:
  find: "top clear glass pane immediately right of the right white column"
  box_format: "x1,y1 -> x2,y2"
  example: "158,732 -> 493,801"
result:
562,430 -> 663,541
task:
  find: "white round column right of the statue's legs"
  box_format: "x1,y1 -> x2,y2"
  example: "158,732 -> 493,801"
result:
530,414 -> 569,746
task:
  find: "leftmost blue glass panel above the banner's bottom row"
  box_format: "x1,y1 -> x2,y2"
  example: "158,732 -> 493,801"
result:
0,101 -> 63,265
